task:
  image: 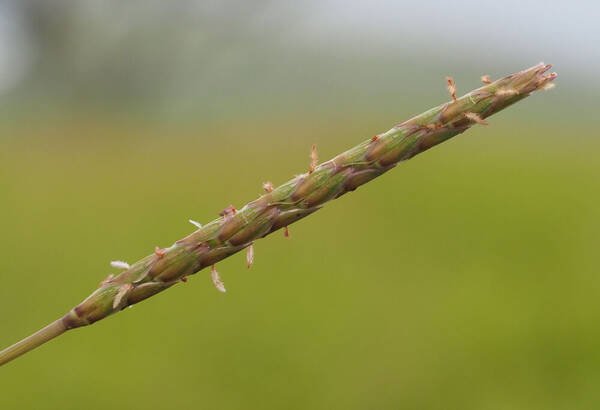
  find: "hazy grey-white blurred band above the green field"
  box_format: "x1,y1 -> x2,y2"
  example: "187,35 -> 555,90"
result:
0,0 -> 600,110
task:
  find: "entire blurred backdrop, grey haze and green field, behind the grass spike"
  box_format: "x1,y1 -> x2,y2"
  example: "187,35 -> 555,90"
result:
0,0 -> 600,410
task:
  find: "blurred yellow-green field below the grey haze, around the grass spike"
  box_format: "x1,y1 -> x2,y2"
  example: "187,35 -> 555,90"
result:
0,107 -> 600,410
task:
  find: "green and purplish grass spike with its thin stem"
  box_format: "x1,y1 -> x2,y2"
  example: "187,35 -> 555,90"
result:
0,64 -> 556,365
